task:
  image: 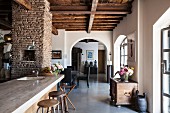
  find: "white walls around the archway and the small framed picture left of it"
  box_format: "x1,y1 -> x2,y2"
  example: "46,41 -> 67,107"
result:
52,30 -> 113,67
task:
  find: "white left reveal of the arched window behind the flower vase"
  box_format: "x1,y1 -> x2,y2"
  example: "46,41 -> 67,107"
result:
114,35 -> 126,78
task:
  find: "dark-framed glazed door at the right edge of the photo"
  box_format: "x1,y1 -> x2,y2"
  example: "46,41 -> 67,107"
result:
161,27 -> 170,113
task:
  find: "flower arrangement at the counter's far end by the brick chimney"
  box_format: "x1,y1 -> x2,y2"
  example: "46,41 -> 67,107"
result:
42,63 -> 64,74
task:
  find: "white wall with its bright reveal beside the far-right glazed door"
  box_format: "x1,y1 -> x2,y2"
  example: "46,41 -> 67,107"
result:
143,0 -> 170,113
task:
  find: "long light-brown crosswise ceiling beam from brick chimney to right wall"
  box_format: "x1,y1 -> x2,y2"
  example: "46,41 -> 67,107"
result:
51,11 -> 131,14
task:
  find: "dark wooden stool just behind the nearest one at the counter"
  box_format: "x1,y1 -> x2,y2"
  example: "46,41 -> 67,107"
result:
48,91 -> 68,113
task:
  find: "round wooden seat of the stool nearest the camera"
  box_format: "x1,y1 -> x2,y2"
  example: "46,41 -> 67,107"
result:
37,99 -> 59,108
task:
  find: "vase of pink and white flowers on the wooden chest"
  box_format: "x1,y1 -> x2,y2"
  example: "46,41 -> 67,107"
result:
115,66 -> 134,82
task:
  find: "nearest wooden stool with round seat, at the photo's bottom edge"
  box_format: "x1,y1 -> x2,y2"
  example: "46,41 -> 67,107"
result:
37,99 -> 59,113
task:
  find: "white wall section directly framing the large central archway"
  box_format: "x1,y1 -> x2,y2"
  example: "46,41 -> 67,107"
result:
66,31 -> 113,65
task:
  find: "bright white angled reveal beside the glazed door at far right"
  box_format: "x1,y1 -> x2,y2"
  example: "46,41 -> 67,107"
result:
152,8 -> 170,113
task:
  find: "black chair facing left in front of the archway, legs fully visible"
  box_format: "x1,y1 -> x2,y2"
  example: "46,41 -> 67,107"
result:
77,66 -> 90,88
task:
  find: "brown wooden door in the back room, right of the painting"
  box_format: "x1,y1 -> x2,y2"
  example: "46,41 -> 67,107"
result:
98,50 -> 105,74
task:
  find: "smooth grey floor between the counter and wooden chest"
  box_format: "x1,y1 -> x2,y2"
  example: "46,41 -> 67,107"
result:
65,74 -> 137,113
